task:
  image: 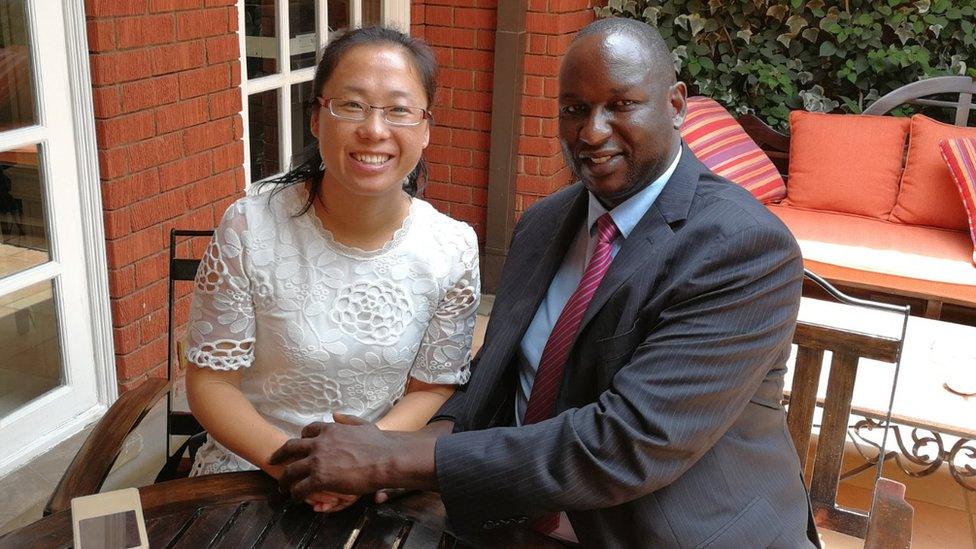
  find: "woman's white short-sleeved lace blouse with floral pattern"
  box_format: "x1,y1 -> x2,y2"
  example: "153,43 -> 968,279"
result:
187,185 -> 480,475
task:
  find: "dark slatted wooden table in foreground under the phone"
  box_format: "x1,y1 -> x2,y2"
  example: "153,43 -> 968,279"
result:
0,472 -> 563,549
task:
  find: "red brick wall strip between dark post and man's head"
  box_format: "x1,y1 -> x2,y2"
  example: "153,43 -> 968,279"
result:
515,0 -> 604,213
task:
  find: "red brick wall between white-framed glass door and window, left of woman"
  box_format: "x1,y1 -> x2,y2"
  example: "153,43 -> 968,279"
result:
85,0 -> 244,390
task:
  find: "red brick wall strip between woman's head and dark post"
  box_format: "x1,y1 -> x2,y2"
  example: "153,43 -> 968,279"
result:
410,0 -> 496,242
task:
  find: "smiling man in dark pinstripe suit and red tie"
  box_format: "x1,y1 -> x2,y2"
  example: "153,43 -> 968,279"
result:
274,19 -> 817,548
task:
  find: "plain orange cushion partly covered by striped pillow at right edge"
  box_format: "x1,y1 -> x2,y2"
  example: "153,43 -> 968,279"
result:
891,114 -> 976,231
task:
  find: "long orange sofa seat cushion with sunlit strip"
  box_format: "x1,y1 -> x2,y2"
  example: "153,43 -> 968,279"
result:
768,204 -> 976,307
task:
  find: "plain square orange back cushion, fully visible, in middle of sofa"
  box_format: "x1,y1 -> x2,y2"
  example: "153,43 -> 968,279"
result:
786,111 -> 909,219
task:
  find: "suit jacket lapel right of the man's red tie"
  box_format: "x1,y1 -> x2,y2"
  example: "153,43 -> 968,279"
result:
574,143 -> 704,332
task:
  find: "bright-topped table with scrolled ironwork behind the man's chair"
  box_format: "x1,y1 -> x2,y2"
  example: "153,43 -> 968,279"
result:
786,298 -> 976,491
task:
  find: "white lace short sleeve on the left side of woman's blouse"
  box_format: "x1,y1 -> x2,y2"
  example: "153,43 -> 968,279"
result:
186,202 -> 255,370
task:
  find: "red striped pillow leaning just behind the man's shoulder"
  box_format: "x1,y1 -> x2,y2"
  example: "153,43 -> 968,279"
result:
681,96 -> 786,203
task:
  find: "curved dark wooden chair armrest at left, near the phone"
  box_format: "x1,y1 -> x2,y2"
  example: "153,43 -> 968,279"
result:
44,379 -> 170,515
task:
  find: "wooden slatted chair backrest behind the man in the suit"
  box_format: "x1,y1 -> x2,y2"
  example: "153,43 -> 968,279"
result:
787,272 -> 904,538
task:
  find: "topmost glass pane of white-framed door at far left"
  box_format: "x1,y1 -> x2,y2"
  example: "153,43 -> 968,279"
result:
0,0 -> 36,130
